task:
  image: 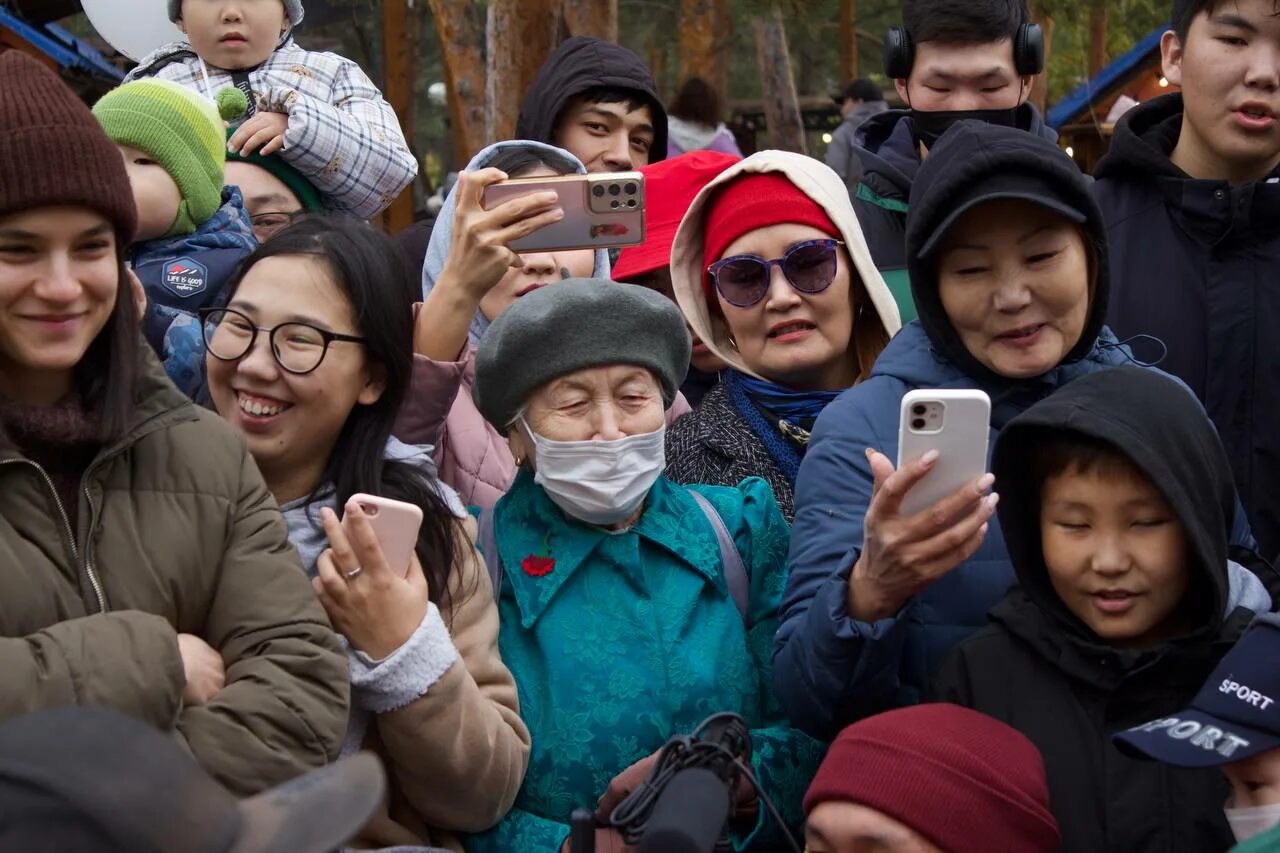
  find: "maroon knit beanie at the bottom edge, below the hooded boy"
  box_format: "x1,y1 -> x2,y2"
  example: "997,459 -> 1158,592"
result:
804,704 -> 1060,853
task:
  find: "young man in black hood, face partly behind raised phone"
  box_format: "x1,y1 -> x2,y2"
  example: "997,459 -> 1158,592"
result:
516,36 -> 667,172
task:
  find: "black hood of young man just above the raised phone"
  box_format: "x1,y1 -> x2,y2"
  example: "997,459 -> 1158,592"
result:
516,36 -> 667,163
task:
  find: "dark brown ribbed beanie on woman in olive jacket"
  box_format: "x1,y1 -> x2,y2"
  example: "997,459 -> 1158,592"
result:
0,50 -> 138,242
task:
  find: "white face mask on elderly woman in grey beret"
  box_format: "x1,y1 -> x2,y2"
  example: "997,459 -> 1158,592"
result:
521,419 -> 667,525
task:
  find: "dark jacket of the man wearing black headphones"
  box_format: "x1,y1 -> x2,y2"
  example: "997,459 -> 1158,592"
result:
852,104 -> 1057,325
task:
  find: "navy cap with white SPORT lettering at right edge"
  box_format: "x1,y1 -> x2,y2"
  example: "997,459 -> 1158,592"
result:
1112,613 -> 1280,767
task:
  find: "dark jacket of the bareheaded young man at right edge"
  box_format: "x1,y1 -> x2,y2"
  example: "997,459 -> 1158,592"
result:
1093,93 -> 1280,561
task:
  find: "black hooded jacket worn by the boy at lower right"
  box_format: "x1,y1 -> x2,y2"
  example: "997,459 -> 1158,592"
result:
932,368 -> 1253,853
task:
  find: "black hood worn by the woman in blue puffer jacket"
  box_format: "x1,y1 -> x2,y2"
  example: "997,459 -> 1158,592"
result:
906,122 -> 1111,382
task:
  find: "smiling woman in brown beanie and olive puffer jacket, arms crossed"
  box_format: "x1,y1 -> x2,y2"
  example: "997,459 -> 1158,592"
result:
0,50 -> 347,794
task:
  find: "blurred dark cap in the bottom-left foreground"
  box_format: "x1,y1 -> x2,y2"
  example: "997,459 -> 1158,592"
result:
0,707 -> 387,853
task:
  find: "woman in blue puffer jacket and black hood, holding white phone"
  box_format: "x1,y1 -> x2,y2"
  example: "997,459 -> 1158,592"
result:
773,122 -> 1252,738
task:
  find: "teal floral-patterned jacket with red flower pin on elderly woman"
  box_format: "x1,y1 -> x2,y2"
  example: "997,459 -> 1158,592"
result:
467,471 -> 824,853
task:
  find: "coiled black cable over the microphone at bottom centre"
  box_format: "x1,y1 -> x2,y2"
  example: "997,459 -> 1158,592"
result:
608,713 -> 800,853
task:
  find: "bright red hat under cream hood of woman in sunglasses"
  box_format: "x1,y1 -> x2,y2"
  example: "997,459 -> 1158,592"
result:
703,172 -> 841,298
